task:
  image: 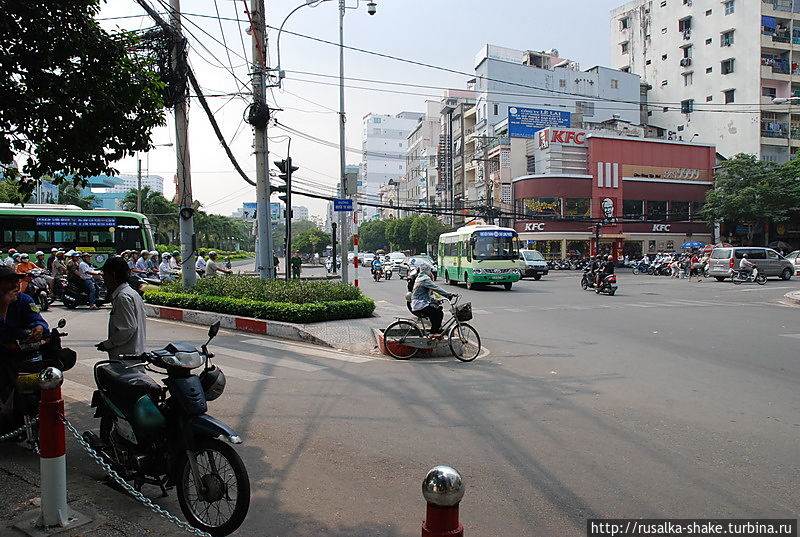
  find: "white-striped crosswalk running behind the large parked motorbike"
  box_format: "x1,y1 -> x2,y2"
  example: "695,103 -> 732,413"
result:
62,338 -> 378,404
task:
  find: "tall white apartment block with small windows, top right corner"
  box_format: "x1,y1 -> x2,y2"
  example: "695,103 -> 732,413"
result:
611,0 -> 800,162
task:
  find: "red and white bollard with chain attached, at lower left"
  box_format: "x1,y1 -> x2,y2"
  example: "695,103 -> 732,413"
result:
36,367 -> 70,528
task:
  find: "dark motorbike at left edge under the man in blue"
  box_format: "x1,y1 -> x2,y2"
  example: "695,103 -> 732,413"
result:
0,319 -> 77,450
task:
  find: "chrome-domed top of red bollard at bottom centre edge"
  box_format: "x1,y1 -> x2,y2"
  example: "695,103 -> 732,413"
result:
422,466 -> 465,537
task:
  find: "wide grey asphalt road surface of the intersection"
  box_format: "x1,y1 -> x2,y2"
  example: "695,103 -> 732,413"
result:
25,271 -> 800,537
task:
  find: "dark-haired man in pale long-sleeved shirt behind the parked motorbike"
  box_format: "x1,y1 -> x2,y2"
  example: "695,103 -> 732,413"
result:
96,257 -> 147,359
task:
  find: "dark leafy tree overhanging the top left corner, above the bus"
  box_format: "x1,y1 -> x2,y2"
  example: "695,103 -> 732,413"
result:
0,0 -> 164,200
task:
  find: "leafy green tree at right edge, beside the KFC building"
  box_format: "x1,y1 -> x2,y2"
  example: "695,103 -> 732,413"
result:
702,154 -> 800,244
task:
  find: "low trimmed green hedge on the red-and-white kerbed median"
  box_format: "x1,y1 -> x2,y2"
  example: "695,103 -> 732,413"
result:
145,291 -> 375,323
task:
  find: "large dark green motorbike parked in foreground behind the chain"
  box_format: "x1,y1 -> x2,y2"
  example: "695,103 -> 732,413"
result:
83,322 -> 250,537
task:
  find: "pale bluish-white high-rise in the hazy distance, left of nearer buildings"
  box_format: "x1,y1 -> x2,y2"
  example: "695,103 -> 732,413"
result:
358,112 -> 425,220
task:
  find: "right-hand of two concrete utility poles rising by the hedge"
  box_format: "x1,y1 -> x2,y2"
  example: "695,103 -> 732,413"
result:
255,0 -> 276,279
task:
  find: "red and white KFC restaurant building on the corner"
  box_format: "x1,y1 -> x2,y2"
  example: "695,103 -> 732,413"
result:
513,127 -> 716,258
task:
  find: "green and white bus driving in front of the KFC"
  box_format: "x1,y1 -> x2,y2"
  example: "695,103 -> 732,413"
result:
438,224 -> 520,290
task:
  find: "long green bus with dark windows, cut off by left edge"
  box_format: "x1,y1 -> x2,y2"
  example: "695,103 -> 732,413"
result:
0,203 -> 154,264
